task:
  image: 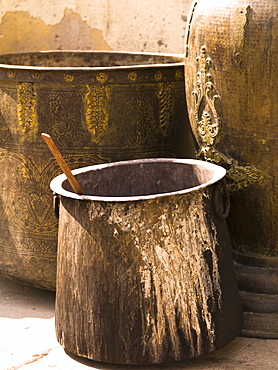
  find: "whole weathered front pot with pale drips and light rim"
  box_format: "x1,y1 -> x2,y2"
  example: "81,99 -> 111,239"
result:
50,159 -> 242,364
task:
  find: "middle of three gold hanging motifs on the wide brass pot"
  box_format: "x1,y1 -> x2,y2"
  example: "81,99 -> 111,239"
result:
86,85 -> 108,143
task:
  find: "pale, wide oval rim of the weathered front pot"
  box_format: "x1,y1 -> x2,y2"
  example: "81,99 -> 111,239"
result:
50,158 -> 226,202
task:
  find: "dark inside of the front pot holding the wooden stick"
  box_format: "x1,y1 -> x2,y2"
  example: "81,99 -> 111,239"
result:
62,159 -> 218,198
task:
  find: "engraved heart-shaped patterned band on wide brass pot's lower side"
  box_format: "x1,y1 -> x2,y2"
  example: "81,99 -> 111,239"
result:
0,150 -> 59,236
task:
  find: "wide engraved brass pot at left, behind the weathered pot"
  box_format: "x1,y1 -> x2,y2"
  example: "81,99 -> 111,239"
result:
0,51 -> 194,290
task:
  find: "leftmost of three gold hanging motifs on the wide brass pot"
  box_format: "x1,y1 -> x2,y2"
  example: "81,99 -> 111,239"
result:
18,83 -> 36,134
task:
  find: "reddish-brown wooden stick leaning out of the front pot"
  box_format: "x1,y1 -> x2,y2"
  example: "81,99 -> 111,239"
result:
41,133 -> 84,195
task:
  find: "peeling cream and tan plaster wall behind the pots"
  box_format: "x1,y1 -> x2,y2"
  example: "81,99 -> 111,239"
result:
0,0 -> 191,53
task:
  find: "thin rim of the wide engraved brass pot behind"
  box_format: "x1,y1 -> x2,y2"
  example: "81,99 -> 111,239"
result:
0,50 -> 184,72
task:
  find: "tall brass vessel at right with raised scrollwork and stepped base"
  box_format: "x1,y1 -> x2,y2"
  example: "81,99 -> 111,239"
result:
185,0 -> 278,338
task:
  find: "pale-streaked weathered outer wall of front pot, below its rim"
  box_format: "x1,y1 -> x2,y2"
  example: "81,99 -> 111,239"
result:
56,191 -> 225,364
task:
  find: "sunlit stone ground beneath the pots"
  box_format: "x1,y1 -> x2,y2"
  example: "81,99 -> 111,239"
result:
0,277 -> 278,370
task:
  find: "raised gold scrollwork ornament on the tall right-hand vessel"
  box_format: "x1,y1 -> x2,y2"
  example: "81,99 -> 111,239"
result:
192,46 -> 262,191
